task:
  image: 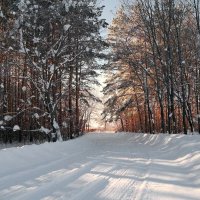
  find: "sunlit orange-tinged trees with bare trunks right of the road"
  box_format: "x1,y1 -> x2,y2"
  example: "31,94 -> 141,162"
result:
104,0 -> 200,134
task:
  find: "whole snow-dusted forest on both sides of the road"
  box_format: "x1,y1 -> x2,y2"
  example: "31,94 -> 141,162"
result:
0,0 -> 200,143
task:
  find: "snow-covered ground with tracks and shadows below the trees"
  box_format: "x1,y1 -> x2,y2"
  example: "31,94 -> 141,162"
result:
0,133 -> 200,200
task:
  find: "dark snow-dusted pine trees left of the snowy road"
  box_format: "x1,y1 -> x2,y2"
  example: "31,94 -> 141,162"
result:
0,0 -> 107,144
